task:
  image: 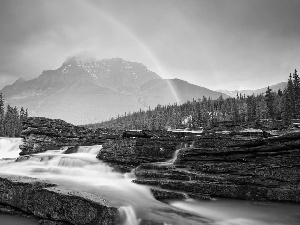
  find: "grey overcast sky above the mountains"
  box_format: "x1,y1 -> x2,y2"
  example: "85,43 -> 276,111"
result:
0,0 -> 300,90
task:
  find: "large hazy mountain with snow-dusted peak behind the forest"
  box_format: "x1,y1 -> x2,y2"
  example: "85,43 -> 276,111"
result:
0,57 -> 228,124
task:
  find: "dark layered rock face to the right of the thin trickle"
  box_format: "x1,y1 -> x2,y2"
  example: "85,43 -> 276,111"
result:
135,132 -> 300,203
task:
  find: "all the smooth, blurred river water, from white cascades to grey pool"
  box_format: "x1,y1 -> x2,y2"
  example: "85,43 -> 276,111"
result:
0,138 -> 300,225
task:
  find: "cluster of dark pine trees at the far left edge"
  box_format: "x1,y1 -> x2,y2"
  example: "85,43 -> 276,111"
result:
0,93 -> 28,137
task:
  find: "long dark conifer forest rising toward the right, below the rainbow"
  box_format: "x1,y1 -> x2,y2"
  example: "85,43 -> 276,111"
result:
86,70 -> 300,130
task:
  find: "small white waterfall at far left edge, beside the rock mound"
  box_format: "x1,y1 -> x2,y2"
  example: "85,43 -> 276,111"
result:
0,138 -> 22,159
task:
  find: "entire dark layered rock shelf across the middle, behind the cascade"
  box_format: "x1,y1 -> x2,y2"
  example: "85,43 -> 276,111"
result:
17,118 -> 300,203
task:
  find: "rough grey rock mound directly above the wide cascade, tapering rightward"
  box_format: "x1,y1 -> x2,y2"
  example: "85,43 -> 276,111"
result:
20,117 -> 121,155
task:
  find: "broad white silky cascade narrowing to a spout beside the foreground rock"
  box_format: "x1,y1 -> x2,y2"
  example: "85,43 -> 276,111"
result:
0,141 -> 156,221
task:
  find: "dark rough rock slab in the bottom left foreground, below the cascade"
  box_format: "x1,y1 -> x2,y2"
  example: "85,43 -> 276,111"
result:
0,174 -> 118,225
